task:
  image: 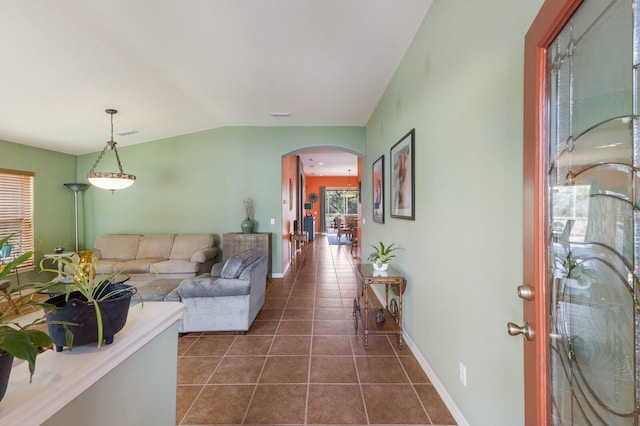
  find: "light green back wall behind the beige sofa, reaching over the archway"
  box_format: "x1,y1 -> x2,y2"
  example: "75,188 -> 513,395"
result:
77,127 -> 365,274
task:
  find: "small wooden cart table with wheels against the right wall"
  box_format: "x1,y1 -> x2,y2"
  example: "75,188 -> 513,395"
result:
352,263 -> 407,350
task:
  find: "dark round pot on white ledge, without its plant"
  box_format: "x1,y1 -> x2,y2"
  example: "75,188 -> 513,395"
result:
45,284 -> 138,352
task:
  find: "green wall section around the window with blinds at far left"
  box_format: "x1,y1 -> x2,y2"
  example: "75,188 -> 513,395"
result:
0,140 -> 76,281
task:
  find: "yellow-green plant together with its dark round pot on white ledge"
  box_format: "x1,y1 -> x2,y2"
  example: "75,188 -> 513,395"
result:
40,257 -> 137,352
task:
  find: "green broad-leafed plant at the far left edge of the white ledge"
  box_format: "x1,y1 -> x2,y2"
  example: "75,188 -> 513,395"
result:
0,234 -> 52,399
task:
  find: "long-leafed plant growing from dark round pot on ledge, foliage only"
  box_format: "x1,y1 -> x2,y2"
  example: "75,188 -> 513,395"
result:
40,253 -> 141,349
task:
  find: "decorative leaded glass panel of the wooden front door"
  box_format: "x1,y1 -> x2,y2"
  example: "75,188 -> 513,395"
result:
547,0 -> 640,426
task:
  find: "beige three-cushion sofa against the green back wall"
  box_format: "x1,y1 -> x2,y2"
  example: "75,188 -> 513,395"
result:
70,234 -> 218,285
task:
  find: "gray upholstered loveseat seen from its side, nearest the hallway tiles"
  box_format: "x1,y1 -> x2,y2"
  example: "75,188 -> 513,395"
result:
139,250 -> 268,333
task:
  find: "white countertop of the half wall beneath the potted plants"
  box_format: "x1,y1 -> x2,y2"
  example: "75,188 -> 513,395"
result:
0,302 -> 182,425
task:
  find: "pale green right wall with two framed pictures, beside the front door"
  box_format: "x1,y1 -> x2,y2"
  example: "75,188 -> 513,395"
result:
362,0 -> 542,426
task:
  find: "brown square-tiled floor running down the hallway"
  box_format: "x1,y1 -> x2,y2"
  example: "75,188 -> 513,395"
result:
176,235 -> 455,425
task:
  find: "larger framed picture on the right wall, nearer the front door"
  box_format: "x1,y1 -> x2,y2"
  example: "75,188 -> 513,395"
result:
390,129 -> 416,220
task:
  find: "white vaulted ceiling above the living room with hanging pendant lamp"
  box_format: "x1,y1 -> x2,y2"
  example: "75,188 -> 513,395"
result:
0,0 -> 432,175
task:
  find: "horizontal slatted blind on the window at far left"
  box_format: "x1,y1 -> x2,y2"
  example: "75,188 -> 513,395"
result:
0,169 -> 34,270
